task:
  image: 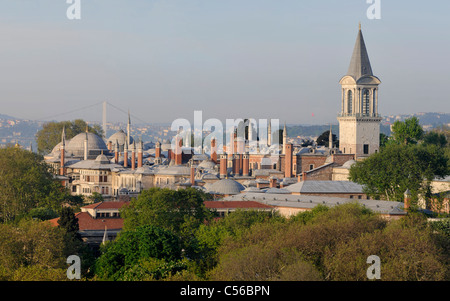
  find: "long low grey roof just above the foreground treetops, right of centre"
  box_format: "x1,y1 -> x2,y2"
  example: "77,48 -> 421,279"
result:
222,192 -> 406,215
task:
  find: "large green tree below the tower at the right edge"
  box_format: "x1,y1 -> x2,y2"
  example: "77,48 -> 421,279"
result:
350,144 -> 448,202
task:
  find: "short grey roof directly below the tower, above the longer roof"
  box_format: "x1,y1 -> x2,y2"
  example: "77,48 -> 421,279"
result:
286,181 -> 363,193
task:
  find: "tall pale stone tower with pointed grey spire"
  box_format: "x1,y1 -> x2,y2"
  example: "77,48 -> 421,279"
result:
337,24 -> 381,158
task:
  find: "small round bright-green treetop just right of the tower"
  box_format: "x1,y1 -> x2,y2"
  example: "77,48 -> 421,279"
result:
391,117 -> 424,145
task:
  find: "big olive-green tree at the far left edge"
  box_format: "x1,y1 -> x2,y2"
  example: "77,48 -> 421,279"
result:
0,147 -> 69,222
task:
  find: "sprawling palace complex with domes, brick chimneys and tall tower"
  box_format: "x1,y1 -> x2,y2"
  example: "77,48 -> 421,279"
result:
45,26 -> 381,200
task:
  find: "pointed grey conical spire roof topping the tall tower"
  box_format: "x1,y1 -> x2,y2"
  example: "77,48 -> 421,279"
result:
347,28 -> 373,80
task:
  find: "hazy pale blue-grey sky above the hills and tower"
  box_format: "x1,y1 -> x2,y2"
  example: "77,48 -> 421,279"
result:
0,0 -> 450,124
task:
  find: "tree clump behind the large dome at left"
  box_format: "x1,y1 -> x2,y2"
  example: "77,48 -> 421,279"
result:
36,119 -> 103,154
